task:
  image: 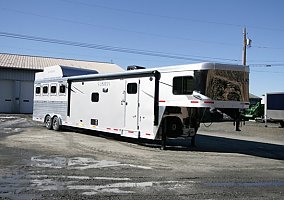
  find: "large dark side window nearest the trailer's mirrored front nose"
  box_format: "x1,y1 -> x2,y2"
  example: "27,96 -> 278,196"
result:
173,76 -> 194,95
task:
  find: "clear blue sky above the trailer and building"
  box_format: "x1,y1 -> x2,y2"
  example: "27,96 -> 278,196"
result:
0,0 -> 284,96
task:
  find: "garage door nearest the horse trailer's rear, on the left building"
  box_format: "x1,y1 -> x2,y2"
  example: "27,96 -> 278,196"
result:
20,81 -> 34,113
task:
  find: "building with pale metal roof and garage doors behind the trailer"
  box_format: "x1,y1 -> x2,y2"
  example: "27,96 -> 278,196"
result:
0,53 -> 124,113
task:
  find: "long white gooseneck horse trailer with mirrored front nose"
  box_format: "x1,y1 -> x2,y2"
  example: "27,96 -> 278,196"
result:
33,63 -> 249,147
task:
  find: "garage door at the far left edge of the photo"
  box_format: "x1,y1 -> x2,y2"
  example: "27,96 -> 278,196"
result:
0,80 -> 14,113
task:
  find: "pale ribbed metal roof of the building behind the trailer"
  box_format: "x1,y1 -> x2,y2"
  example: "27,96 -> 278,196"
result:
0,53 -> 124,73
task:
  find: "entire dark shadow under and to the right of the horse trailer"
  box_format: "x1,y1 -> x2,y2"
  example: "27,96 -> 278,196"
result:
67,129 -> 284,160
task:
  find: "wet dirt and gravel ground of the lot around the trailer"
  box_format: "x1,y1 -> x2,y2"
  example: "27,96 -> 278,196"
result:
0,114 -> 284,199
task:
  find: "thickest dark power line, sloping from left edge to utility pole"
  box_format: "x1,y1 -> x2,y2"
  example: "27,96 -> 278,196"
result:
0,32 -> 240,62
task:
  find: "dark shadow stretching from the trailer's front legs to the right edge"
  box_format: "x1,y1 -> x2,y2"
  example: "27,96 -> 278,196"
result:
167,135 -> 284,160
